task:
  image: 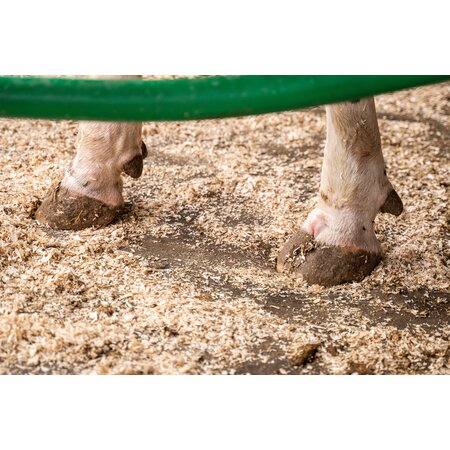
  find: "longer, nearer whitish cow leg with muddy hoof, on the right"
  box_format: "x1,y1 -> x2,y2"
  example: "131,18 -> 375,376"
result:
277,98 -> 403,286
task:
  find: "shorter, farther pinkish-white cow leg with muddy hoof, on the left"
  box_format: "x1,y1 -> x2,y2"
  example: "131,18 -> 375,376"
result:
36,77 -> 147,230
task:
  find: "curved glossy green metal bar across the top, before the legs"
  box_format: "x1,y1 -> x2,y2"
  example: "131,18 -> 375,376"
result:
0,75 -> 450,121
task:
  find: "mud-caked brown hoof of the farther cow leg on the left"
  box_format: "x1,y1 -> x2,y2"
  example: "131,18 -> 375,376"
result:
35,183 -> 122,230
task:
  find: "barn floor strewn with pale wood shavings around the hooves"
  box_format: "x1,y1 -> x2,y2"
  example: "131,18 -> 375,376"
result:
0,84 -> 450,374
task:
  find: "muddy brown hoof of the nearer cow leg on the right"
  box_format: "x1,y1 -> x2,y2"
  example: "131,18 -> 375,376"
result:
277,230 -> 381,287
